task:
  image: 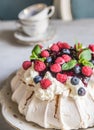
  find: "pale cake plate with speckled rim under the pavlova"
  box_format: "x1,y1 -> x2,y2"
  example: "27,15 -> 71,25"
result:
0,74 -> 94,130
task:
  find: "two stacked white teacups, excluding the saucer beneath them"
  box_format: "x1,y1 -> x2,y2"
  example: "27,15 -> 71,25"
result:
18,4 -> 55,36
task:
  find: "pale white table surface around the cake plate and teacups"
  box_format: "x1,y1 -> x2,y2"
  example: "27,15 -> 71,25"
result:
0,19 -> 94,130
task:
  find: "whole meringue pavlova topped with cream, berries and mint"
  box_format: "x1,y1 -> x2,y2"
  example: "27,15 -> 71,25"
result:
11,42 -> 94,130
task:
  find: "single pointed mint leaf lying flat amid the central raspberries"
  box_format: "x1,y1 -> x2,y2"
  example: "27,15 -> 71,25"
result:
62,60 -> 77,70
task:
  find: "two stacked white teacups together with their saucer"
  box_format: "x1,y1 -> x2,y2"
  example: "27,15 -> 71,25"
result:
14,3 -> 55,42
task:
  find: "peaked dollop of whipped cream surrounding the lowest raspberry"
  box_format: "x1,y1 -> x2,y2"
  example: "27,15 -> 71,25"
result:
34,72 -> 67,100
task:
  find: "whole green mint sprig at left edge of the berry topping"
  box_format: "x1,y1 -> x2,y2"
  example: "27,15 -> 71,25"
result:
30,45 -> 46,62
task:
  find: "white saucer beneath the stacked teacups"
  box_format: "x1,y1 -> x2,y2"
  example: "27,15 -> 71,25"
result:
14,25 -> 56,45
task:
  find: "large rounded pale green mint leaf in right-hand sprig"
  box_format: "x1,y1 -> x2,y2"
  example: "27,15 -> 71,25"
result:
79,49 -> 91,61
